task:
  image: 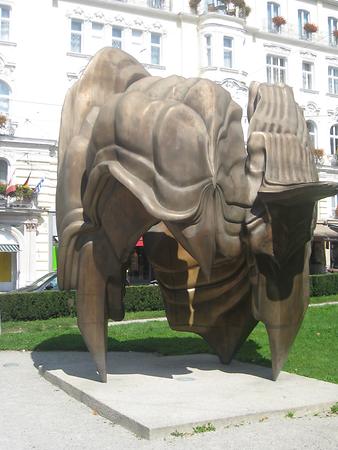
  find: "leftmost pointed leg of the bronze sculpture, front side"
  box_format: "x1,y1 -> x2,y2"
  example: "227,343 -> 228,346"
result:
77,242 -> 107,383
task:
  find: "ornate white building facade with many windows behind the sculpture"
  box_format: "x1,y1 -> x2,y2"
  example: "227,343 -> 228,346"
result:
0,0 -> 338,290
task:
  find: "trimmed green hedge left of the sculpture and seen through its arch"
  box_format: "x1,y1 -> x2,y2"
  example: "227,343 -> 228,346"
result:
0,286 -> 164,322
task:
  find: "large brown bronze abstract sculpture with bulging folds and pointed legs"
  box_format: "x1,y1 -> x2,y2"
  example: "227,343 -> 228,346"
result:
57,48 -> 338,381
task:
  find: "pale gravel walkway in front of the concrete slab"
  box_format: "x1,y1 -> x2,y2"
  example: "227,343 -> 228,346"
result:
0,352 -> 338,450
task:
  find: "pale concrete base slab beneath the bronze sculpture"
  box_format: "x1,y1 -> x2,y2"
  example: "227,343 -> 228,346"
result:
33,352 -> 338,439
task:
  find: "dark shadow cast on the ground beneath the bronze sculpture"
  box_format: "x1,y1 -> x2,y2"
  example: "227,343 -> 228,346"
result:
32,333 -> 271,381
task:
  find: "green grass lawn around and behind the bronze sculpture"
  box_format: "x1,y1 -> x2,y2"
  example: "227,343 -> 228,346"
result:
0,306 -> 338,383
